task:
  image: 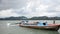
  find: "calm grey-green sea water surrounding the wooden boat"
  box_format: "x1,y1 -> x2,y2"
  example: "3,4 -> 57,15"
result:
0,20 -> 60,34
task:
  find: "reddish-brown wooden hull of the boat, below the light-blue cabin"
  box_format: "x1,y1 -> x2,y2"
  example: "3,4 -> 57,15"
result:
18,21 -> 60,31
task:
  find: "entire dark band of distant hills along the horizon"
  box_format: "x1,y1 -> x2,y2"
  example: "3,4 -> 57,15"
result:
0,16 -> 60,20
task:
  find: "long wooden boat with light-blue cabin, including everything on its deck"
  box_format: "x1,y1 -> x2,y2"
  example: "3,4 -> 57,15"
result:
18,22 -> 60,31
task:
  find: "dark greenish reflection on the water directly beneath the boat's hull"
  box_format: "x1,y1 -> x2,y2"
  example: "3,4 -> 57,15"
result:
20,27 -> 60,34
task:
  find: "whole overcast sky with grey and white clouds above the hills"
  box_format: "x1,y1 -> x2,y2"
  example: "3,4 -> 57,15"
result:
0,0 -> 60,18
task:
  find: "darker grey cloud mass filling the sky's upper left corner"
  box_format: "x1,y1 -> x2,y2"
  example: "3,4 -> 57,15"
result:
0,0 -> 27,10
